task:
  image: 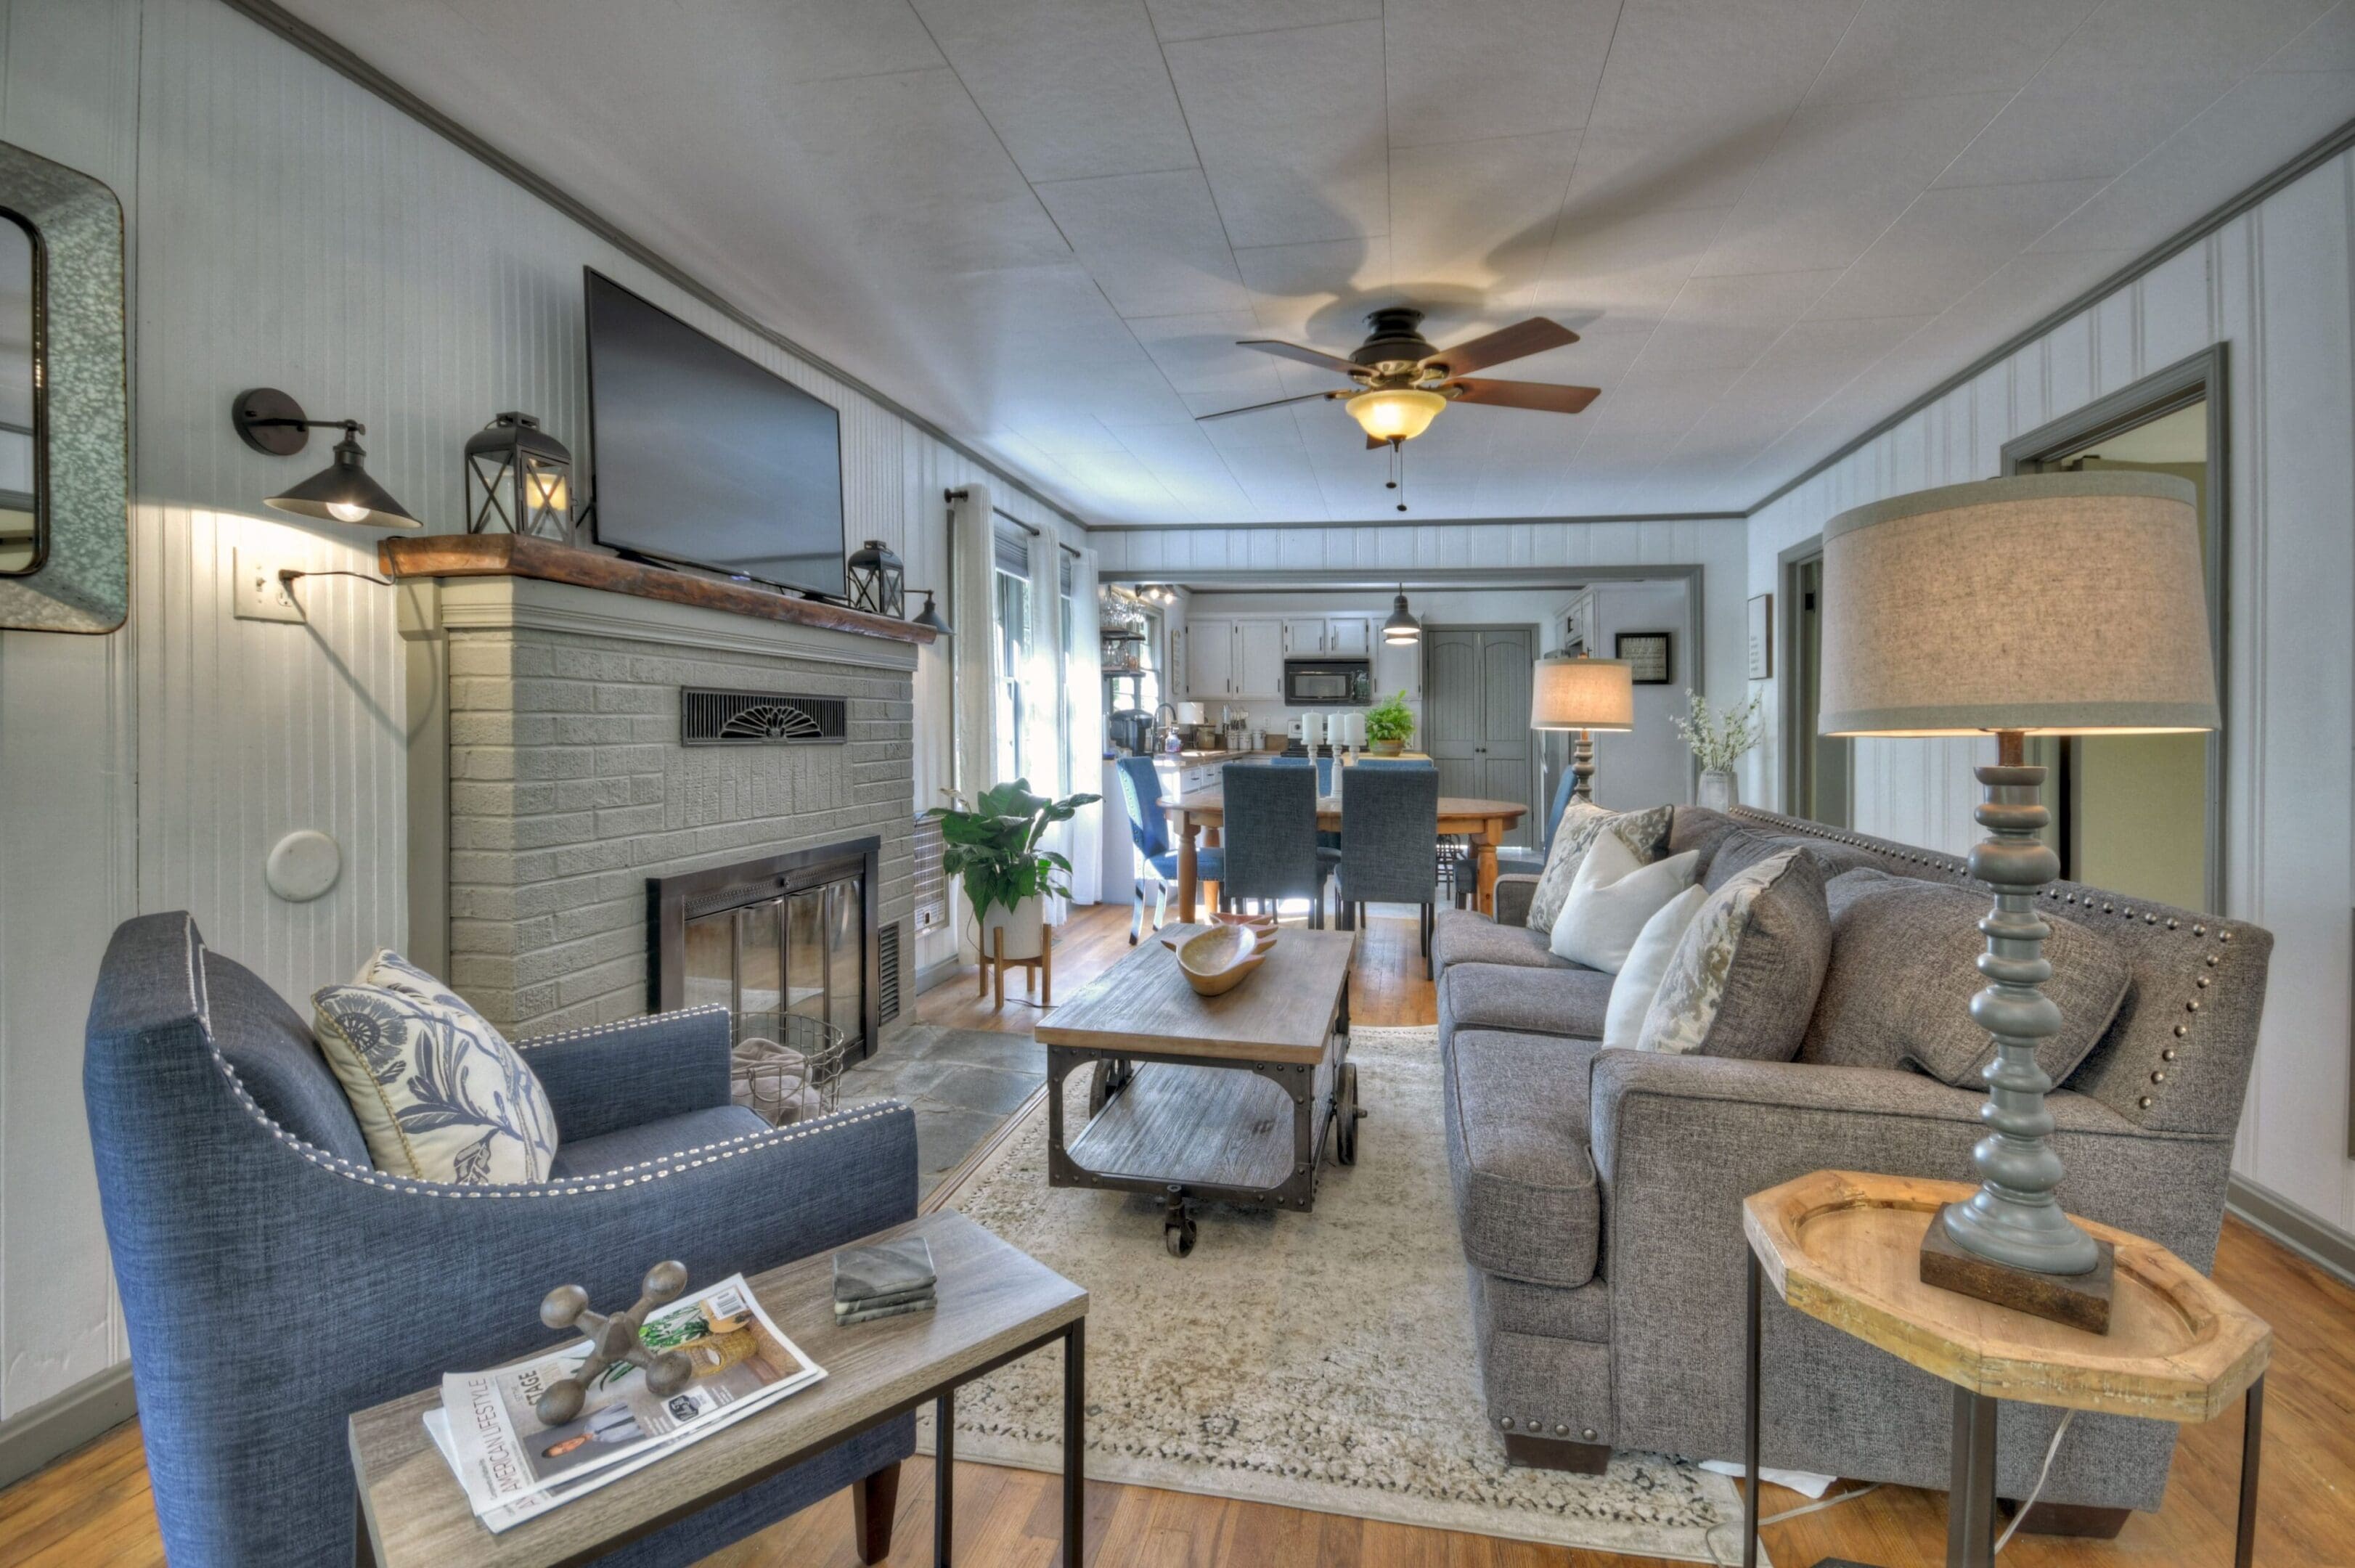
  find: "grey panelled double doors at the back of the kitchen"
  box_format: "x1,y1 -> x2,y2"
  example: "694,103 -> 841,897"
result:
1422,626 -> 1538,848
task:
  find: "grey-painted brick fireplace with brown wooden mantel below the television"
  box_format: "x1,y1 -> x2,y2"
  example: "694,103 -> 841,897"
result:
384,534 -> 921,1048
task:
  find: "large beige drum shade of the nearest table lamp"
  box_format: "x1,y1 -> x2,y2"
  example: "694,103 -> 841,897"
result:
1821,471 -> 2219,735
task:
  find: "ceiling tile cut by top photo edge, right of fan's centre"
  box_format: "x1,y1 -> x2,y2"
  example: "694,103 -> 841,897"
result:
1382,0 -> 1620,146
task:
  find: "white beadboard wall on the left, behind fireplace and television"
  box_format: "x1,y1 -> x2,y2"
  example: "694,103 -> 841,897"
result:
0,0 -> 1083,1420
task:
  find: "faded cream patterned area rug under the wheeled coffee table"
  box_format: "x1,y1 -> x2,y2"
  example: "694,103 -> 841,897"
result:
918,1026 -> 1771,1564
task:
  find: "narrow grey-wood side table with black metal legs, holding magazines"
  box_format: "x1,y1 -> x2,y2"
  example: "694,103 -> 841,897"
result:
351,1212 -> 1088,1568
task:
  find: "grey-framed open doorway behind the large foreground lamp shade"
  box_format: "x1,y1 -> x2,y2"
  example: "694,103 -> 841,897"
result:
2004,348 -> 2230,909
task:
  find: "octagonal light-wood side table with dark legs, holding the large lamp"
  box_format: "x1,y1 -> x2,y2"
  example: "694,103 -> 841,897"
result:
1743,1170 -> 2272,1568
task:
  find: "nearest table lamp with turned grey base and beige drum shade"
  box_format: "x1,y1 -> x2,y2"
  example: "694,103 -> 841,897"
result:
1821,471 -> 2219,1333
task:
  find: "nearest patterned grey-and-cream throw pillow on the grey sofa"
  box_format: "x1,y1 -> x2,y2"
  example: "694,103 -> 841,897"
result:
1641,845 -> 1832,1062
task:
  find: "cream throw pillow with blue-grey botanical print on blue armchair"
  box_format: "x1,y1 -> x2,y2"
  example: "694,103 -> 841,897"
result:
311,951 -> 556,1187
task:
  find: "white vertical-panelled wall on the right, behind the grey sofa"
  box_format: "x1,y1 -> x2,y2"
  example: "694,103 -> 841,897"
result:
1745,155 -> 2355,1233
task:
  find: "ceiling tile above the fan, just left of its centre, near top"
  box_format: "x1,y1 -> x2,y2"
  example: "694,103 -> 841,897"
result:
1164,21 -> 1389,245
